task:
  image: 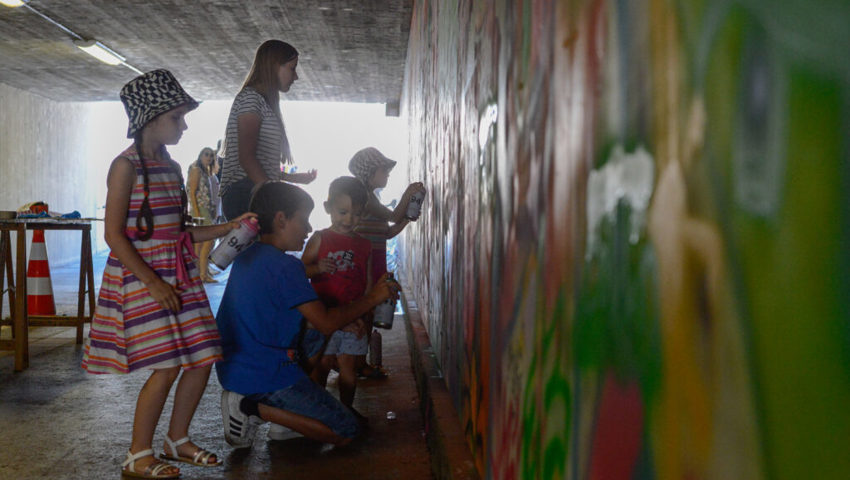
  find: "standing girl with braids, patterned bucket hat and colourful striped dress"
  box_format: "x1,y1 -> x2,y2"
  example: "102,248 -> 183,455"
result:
83,70 -> 255,478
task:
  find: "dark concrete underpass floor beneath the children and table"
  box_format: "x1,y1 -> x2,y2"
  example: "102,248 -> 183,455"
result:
0,251 -> 433,480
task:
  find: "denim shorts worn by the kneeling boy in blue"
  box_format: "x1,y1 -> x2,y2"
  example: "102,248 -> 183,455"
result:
248,376 -> 360,438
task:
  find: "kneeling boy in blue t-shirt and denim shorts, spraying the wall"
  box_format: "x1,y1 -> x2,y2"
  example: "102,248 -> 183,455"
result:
216,182 -> 400,448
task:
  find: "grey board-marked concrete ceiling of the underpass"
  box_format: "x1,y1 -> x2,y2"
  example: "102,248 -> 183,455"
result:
0,0 -> 413,103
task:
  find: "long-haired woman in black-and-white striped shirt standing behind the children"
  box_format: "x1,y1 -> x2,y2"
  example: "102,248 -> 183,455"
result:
219,40 -> 316,219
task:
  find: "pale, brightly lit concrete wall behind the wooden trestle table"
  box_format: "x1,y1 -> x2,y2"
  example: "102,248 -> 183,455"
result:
0,84 -> 129,265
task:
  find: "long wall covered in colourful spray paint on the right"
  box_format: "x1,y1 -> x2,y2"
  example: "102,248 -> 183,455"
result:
403,0 -> 850,479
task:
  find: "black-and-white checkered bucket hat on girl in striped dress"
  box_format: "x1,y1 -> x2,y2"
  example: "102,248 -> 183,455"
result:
120,69 -> 198,138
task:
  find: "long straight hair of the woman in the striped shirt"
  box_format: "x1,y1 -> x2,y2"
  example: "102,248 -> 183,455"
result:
242,40 -> 298,164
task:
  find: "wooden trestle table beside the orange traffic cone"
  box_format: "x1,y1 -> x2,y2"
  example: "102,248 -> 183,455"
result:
0,218 -> 94,372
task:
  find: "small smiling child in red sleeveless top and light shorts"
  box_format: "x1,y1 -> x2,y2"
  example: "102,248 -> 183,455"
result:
301,177 -> 372,420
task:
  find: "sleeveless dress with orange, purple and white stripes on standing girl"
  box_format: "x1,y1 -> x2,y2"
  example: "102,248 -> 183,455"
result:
83,147 -> 222,373
